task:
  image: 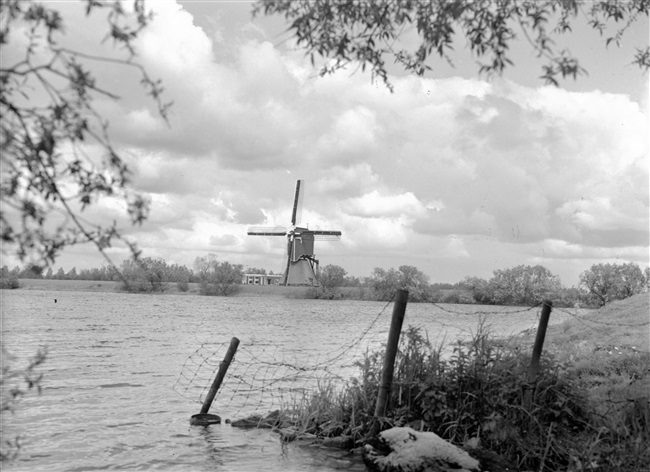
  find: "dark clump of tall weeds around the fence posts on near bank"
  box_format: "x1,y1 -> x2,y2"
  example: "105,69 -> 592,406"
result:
284,327 -> 650,472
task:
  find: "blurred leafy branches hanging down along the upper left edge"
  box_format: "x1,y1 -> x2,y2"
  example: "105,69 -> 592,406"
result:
0,0 -> 168,266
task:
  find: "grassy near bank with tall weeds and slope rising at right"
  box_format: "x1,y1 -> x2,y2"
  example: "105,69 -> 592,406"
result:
280,294 -> 650,472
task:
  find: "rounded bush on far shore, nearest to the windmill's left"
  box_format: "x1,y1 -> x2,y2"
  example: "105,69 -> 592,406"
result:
194,254 -> 244,296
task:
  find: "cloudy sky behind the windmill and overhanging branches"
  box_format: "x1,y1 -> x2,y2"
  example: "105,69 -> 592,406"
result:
3,0 -> 650,286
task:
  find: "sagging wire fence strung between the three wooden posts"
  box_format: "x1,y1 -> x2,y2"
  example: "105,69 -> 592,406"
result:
174,294 -> 650,417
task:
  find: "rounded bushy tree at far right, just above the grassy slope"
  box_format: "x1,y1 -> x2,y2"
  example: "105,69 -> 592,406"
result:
580,262 -> 647,306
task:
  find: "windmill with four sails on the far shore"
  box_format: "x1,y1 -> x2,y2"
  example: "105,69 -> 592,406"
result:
247,180 -> 341,285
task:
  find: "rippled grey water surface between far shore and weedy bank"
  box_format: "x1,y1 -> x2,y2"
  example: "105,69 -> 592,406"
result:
1,290 -> 559,472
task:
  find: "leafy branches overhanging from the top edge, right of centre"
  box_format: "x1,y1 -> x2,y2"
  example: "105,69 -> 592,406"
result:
253,0 -> 650,88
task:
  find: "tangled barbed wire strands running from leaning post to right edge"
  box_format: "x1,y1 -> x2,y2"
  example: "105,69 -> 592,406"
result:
173,300 -> 650,415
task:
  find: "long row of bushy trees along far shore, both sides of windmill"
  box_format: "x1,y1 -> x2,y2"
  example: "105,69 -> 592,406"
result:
1,254 -> 650,306
